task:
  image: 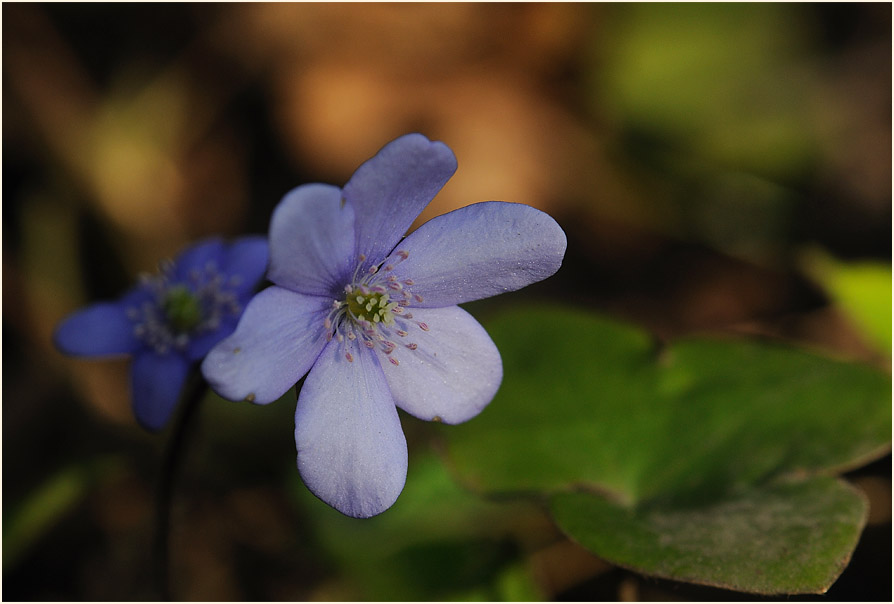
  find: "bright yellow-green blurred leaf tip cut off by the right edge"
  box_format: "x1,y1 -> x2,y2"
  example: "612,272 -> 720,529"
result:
806,252 -> 891,358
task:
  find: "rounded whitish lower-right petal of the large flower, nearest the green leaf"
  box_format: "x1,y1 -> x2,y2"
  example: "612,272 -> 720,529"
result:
382,306 -> 503,424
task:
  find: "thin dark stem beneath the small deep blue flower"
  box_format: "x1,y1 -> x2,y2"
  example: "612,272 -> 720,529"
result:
154,371 -> 208,601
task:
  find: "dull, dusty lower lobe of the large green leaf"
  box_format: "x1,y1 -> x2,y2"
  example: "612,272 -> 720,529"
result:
552,478 -> 867,594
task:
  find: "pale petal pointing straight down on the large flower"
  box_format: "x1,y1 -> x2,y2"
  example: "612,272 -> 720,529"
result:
295,340 -> 407,518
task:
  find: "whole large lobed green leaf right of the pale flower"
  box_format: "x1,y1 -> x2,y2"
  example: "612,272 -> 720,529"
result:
447,309 -> 891,593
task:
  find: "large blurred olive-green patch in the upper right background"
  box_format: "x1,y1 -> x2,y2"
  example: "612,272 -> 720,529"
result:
593,3 -> 815,175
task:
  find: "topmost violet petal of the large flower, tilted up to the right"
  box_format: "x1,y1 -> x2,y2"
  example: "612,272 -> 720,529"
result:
344,134 -> 456,266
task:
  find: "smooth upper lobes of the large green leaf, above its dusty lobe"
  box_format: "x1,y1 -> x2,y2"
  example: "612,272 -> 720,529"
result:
446,309 -> 891,589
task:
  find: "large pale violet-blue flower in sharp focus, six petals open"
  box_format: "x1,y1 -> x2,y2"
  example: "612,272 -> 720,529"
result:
202,134 -> 566,518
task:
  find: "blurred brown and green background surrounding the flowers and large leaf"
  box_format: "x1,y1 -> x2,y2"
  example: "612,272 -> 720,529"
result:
2,3 -> 892,600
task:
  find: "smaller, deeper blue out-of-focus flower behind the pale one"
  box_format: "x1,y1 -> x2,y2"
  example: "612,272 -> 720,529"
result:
54,237 -> 268,431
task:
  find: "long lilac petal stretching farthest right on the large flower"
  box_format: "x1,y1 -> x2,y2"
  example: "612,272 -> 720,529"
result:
394,201 -> 566,307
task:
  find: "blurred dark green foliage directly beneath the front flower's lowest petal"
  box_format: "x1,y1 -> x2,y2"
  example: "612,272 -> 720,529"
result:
296,450 -> 542,601
